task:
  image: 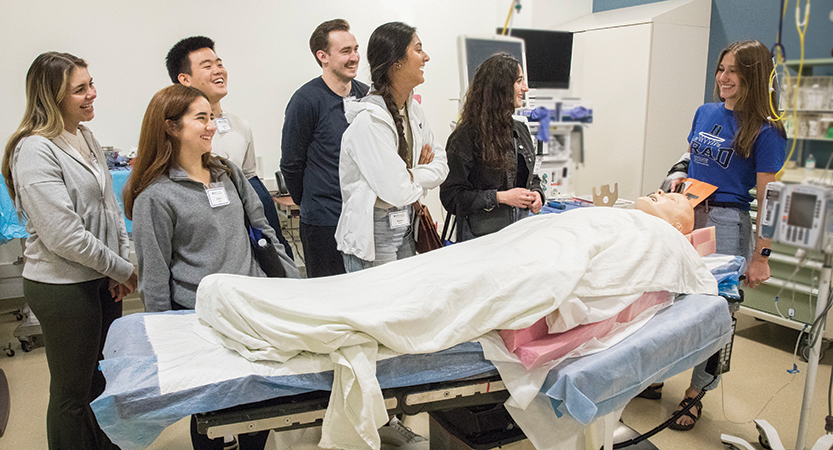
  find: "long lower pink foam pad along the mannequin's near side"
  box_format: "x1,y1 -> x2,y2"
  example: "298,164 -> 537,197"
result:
510,291 -> 672,369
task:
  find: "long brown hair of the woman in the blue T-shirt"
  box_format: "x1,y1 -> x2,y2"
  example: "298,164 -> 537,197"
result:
714,40 -> 787,158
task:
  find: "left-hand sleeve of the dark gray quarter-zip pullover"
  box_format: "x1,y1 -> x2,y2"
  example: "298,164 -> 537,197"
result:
133,191 -> 174,312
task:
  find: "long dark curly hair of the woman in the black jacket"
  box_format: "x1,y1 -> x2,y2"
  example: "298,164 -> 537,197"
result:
459,53 -> 520,169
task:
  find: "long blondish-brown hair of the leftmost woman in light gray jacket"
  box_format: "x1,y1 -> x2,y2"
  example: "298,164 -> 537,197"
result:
2,52 -> 87,201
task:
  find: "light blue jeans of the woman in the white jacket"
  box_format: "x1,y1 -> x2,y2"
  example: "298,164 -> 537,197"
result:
342,205 -> 416,272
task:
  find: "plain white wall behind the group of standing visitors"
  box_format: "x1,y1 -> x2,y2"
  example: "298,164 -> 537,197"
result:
0,0 -> 500,182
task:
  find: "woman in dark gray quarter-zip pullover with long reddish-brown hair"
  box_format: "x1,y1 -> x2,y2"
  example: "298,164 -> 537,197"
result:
124,84 -> 298,450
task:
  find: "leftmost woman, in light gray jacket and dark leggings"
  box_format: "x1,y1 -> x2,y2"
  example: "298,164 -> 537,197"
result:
3,52 -> 137,450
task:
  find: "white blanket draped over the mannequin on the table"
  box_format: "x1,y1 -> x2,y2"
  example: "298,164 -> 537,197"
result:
197,208 -> 717,449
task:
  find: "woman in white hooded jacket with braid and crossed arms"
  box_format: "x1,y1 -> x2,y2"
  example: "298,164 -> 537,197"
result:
336,22 -> 448,272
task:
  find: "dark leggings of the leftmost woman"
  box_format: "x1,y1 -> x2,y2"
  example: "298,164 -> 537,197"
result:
23,278 -> 122,450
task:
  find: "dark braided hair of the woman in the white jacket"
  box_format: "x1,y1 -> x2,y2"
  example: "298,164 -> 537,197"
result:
367,22 -> 416,167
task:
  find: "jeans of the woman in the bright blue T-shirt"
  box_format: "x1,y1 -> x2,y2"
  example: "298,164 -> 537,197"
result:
691,205 -> 752,391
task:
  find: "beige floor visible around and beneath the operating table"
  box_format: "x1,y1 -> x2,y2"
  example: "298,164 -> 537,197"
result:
0,296 -> 833,450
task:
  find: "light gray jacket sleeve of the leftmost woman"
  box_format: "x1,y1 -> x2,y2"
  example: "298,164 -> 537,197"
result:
14,137 -> 133,283
